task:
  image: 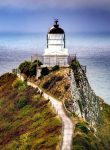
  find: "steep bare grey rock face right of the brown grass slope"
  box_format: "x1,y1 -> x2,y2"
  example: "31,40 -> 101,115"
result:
67,67 -> 100,125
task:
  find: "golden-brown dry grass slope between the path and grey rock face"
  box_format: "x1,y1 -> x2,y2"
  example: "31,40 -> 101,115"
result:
39,68 -> 70,101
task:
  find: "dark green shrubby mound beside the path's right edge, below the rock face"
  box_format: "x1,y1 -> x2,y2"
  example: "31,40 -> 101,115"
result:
72,120 -> 104,150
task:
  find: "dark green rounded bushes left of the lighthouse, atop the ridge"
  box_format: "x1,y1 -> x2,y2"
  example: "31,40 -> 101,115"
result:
19,60 -> 42,77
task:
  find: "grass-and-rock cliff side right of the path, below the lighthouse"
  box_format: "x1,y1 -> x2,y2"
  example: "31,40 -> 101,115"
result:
39,60 -> 110,150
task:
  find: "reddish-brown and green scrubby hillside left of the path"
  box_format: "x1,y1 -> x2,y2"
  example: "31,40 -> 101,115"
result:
0,73 -> 61,150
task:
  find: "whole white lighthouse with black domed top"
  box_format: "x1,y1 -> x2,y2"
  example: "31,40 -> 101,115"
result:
43,19 -> 69,67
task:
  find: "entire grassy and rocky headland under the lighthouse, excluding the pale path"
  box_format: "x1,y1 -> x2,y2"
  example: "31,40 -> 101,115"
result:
0,59 -> 110,150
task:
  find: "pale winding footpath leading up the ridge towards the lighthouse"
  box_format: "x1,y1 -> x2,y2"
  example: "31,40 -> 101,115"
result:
17,74 -> 74,150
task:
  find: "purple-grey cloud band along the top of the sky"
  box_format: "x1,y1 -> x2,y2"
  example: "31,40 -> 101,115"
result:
0,0 -> 110,9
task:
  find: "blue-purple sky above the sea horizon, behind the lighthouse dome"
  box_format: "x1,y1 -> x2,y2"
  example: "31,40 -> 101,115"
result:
0,0 -> 110,33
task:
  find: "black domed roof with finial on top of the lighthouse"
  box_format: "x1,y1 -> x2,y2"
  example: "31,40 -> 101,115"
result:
48,19 -> 65,34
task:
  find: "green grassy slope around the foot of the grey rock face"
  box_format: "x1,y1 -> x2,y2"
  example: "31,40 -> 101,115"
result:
72,98 -> 110,150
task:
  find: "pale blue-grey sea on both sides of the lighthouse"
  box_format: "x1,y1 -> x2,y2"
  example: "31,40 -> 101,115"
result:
0,33 -> 110,104
